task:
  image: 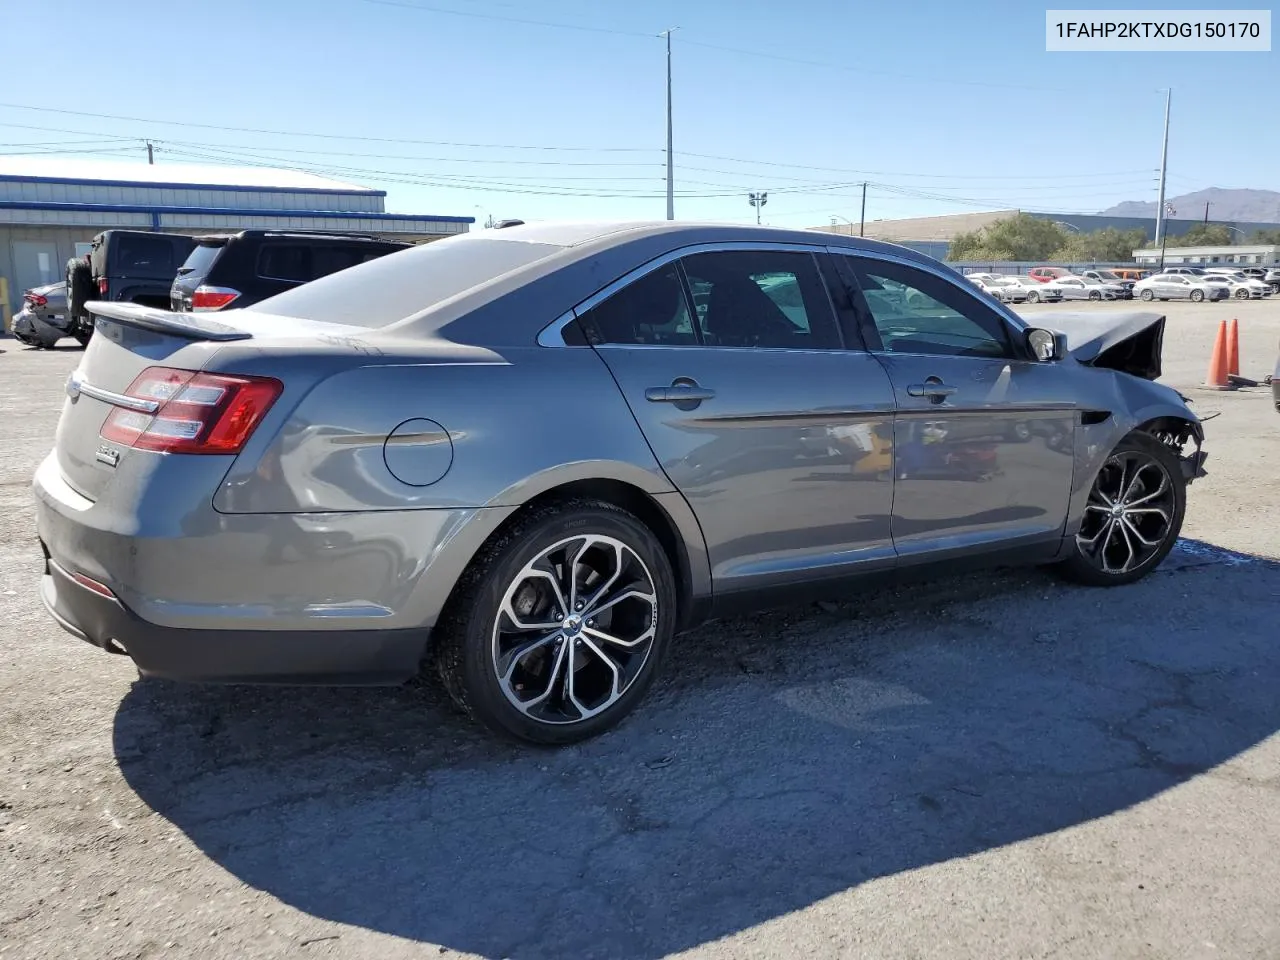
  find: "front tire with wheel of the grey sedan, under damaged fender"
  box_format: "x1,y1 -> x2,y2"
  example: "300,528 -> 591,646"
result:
1057,431 -> 1187,586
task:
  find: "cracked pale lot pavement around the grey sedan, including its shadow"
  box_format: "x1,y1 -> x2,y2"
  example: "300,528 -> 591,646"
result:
0,303 -> 1280,960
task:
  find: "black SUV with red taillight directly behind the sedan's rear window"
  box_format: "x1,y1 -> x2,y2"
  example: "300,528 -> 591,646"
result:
169,230 -> 413,312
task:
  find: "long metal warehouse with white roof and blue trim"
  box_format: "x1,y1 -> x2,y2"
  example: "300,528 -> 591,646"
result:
0,156 -> 475,317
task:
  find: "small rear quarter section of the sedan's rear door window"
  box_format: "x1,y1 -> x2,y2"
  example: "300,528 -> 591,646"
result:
579,264 -> 698,347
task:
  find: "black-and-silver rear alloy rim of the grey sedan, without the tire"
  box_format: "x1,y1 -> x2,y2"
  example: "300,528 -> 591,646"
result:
490,534 -> 658,724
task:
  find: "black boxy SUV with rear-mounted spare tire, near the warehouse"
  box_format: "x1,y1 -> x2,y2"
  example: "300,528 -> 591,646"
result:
67,230 -> 196,323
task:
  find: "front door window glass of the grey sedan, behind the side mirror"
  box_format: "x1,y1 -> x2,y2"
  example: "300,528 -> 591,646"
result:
851,257 -> 1011,357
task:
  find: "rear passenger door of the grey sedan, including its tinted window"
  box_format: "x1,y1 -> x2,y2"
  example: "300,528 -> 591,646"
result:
580,248 -> 893,593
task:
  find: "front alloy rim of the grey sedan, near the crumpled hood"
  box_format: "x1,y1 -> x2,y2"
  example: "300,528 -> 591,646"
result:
1075,451 -> 1175,576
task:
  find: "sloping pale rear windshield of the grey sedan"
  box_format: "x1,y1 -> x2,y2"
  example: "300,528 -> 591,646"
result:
255,236 -> 563,328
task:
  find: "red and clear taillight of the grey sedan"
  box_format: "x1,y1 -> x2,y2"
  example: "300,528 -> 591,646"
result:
102,366 -> 284,453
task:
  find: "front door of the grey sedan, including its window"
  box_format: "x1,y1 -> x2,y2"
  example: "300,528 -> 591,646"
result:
840,256 -> 1076,559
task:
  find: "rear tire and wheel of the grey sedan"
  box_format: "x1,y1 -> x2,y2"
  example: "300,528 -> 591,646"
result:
435,500 -> 677,745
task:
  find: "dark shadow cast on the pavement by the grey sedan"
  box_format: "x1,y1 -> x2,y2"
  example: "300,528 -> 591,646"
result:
114,541 -> 1280,957
